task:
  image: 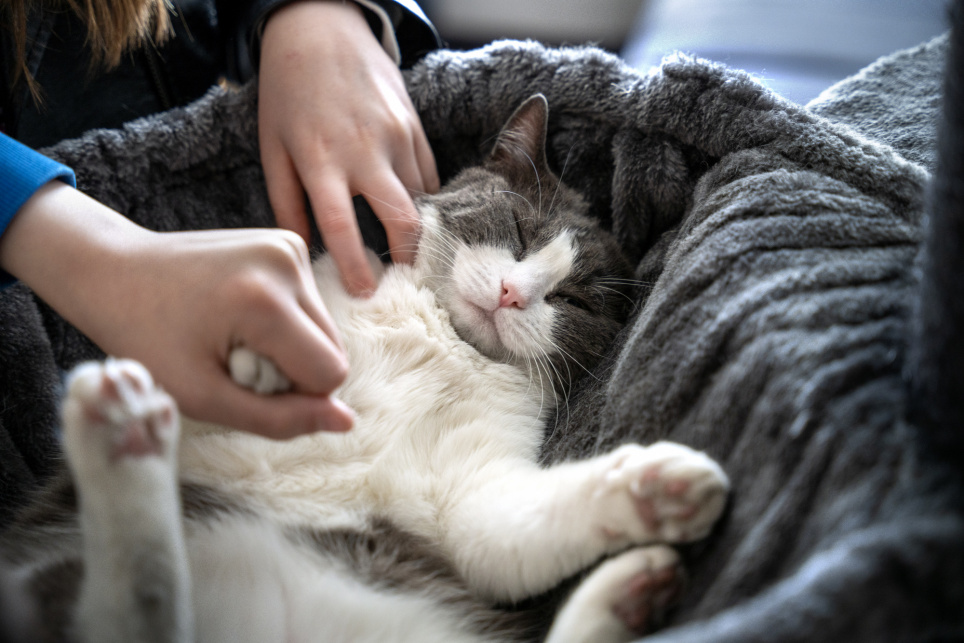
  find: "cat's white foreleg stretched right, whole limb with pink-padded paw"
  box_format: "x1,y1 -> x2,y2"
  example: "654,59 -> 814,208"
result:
442,442 -> 729,600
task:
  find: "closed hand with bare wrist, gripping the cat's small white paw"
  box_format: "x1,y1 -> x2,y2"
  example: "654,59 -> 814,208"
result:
0,181 -> 353,438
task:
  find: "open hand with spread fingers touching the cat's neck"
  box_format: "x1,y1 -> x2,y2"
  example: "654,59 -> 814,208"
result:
258,0 -> 439,295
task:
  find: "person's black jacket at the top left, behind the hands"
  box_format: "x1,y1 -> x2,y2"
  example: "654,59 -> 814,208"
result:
0,0 -> 439,149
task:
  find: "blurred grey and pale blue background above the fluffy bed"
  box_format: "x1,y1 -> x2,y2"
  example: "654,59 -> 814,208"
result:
420,0 -> 947,103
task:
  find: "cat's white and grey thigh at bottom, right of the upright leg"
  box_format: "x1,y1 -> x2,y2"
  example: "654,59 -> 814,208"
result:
188,512 -> 518,643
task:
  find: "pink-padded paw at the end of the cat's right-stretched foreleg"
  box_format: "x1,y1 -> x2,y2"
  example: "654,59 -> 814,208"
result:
595,442 -> 729,543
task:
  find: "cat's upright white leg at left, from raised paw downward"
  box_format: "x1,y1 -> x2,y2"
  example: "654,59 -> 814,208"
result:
63,360 -> 193,643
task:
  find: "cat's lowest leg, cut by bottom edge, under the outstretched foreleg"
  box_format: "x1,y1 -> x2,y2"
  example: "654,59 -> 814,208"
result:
546,545 -> 684,643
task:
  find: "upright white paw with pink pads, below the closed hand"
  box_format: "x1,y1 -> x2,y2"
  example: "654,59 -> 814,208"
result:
62,359 -> 179,467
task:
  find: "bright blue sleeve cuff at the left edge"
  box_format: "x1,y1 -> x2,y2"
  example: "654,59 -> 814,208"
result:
0,134 -> 77,287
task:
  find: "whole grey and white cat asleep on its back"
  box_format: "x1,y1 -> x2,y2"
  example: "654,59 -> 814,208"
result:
0,95 -> 728,643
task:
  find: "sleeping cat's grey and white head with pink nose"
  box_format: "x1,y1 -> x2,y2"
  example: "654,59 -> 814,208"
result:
419,94 -> 632,390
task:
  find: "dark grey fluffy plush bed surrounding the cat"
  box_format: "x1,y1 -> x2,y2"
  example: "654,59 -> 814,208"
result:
0,34 -> 964,643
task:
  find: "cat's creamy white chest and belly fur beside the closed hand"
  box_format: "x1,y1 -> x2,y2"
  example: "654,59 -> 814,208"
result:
179,267 -> 549,527
